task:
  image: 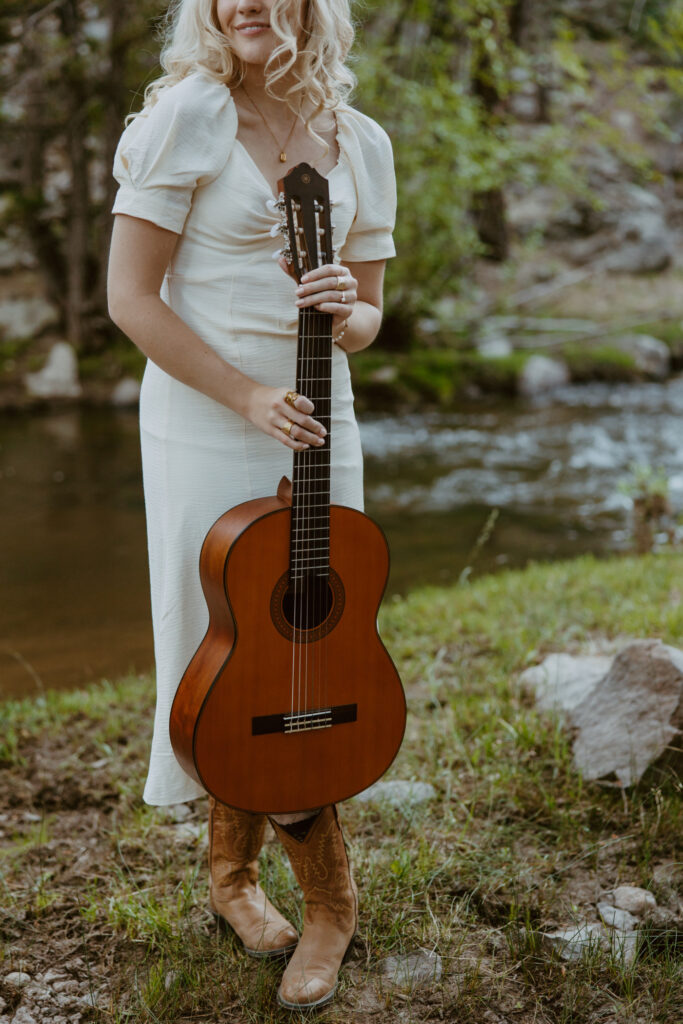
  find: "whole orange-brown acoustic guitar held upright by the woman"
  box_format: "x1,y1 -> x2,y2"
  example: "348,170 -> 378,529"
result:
170,164 -> 405,814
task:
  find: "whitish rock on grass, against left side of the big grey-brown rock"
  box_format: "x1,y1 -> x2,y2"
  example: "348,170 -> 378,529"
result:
519,653 -> 612,712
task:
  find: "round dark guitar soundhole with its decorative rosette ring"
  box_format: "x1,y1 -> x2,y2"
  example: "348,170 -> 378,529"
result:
270,569 -> 344,643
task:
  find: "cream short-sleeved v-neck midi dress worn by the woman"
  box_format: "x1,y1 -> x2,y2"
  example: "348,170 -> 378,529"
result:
114,73 -> 396,805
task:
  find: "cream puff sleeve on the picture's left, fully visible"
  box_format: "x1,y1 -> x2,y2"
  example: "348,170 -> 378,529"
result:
112,74 -> 238,234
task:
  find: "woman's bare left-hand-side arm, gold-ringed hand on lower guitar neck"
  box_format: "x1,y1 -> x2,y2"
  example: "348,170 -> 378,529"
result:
108,214 -> 325,451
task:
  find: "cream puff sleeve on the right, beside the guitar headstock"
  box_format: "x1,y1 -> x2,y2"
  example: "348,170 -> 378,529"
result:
338,106 -> 396,262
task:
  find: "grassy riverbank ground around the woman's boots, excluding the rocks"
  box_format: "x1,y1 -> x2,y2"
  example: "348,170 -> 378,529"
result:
0,550 -> 683,1024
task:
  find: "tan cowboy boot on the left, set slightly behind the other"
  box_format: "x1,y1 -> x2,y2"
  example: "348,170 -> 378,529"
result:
209,797 -> 299,956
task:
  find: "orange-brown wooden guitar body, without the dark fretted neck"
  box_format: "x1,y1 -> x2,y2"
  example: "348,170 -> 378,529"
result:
171,498 -> 405,813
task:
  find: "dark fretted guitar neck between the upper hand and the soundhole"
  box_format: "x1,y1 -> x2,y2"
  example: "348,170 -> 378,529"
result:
290,309 -> 333,581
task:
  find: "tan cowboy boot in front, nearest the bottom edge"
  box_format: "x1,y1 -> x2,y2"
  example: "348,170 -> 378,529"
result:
271,805 -> 358,1010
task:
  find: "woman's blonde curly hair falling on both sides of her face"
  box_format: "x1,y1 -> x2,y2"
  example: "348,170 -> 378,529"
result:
137,0 -> 355,117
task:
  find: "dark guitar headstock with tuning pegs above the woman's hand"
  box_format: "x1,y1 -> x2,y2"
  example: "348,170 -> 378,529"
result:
275,164 -> 334,281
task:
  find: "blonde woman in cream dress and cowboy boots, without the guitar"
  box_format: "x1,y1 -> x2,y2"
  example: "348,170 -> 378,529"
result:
109,0 -> 395,1009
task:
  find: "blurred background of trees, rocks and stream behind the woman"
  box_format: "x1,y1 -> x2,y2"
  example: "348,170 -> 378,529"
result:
0,0 -> 683,694
